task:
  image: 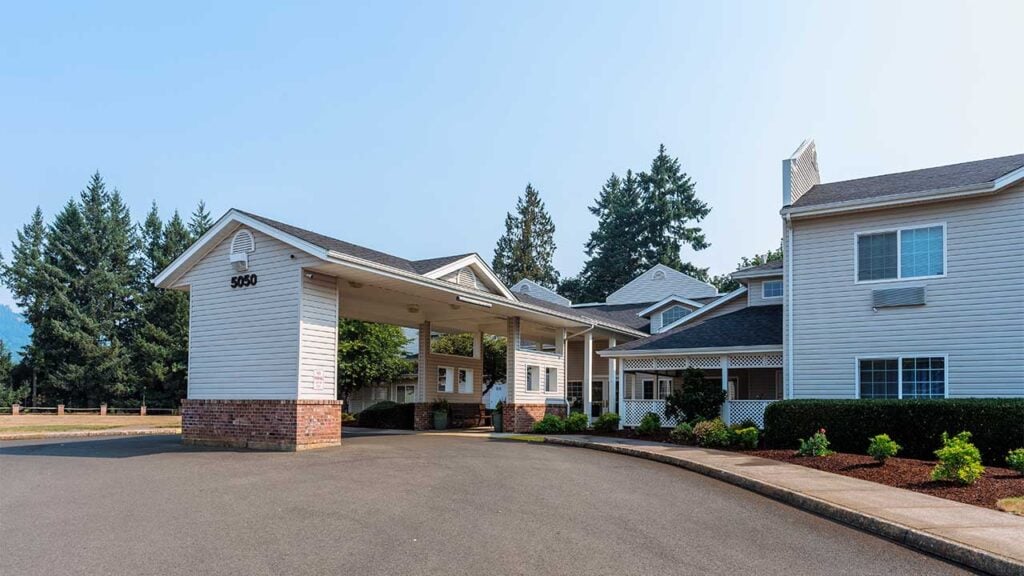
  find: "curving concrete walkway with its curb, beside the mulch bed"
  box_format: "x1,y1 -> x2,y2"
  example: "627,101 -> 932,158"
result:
546,436 -> 1024,576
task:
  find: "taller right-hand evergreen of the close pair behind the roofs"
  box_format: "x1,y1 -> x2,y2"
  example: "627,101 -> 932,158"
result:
638,145 -> 711,276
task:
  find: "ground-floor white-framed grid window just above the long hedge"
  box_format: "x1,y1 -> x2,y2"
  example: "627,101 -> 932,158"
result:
857,356 -> 948,399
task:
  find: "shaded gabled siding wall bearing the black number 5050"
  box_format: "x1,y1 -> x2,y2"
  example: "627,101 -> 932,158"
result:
181,226 -> 321,400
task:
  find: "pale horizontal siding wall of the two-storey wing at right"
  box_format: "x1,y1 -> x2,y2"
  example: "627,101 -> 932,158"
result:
786,181 -> 1024,398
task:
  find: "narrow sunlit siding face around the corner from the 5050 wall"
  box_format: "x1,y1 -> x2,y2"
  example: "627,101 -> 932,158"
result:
299,274 -> 338,400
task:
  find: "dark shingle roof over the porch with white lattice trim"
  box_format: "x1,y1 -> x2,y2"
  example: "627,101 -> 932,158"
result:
613,305 -> 782,352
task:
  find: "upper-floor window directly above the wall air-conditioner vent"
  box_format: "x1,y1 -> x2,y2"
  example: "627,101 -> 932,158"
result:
856,224 -> 946,282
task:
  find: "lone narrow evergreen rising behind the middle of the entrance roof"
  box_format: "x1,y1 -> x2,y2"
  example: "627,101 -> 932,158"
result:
492,184 -> 558,289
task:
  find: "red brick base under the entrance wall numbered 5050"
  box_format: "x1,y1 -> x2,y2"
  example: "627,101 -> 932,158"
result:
181,400 -> 341,450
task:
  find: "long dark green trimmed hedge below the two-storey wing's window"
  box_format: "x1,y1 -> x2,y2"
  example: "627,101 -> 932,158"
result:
765,398 -> 1024,465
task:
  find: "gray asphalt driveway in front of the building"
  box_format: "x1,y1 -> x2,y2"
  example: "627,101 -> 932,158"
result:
0,435 -> 965,576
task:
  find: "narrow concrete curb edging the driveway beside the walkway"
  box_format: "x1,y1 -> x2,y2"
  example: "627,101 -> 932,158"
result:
545,437 -> 1024,576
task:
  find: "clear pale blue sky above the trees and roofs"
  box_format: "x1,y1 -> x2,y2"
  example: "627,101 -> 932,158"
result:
0,1 -> 1024,303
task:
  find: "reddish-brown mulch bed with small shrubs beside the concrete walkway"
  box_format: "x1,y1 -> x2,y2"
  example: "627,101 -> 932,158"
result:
744,450 -> 1024,509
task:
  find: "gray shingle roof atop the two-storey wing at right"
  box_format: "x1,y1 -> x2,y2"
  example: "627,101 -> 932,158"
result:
793,154 -> 1024,208
